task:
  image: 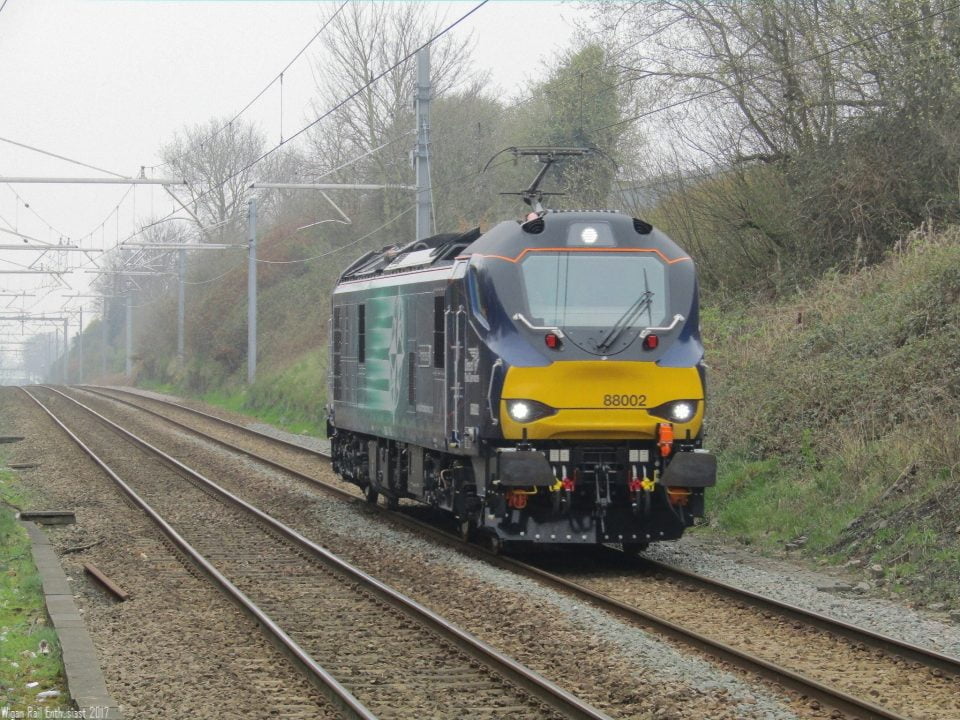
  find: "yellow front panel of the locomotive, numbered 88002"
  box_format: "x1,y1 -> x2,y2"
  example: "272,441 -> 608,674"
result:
500,360 -> 703,440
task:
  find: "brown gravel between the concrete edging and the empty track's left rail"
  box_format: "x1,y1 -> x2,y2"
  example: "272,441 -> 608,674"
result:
0,388 -> 339,718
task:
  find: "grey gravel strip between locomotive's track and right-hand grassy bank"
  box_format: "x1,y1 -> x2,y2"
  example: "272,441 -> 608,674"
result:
645,535 -> 960,657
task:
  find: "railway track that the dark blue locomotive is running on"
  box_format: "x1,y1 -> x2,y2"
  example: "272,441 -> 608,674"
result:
79,388 -> 960,720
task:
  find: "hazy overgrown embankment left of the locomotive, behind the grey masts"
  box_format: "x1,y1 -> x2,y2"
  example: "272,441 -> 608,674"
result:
114,217 -> 344,436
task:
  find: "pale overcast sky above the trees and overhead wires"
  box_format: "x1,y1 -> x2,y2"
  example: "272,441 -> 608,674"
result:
0,0 -> 587,348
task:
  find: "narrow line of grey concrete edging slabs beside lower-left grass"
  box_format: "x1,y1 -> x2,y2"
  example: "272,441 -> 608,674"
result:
20,520 -> 123,720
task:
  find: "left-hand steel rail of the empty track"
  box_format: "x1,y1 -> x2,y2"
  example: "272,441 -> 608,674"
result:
20,387 -> 377,720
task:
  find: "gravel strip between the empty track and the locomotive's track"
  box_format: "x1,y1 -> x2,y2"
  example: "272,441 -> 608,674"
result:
69,388 -> 804,719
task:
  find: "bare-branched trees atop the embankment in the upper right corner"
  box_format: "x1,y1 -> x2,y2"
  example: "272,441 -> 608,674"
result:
597,0 -> 960,286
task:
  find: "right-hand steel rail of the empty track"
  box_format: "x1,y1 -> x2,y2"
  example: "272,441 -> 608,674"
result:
37,386 -> 611,720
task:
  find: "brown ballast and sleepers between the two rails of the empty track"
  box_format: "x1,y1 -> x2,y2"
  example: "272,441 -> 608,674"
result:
41,388 -> 557,720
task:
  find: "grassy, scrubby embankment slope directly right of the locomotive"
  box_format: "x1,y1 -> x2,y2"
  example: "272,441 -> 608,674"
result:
703,228 -> 960,600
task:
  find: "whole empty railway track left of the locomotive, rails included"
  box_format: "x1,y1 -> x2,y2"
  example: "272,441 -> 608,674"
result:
24,387 -> 607,720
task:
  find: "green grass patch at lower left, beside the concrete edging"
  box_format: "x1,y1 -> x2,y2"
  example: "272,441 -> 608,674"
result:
0,454 -> 70,712
